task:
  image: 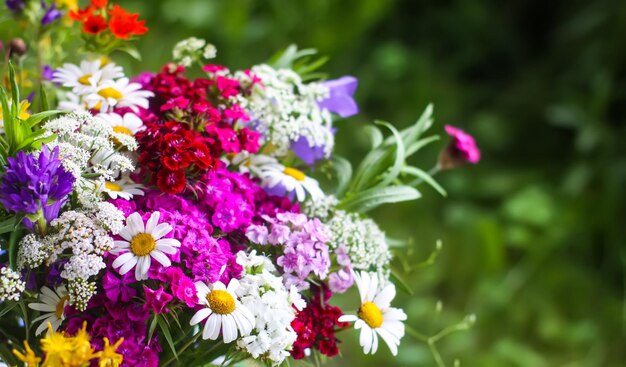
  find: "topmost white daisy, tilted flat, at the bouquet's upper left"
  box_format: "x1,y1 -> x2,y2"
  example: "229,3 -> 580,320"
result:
52,59 -> 124,95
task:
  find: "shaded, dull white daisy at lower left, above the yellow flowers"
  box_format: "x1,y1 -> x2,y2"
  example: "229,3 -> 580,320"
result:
28,285 -> 70,335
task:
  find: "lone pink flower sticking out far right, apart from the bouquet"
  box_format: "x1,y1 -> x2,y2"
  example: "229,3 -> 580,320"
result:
439,125 -> 480,169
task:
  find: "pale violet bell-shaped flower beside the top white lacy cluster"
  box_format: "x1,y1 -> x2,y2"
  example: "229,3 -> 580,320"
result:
318,75 -> 359,118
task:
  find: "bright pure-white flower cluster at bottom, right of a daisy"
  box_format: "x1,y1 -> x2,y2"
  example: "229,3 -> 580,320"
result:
236,251 -> 304,366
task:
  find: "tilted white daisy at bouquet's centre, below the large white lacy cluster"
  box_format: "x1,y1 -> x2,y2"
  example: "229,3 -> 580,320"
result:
259,163 -> 324,201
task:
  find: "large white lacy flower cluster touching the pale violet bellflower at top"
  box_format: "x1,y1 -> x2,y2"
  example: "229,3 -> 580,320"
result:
235,65 -> 335,157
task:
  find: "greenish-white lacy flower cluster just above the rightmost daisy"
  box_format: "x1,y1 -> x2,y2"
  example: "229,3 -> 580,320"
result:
326,210 -> 391,273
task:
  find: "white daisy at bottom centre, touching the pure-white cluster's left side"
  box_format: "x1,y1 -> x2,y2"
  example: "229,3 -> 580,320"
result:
189,279 -> 254,343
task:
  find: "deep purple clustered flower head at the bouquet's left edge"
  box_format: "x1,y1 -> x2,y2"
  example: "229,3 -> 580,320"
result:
0,145 -> 75,234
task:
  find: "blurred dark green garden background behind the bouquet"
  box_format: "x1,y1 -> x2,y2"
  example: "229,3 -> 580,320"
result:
9,0 -> 626,367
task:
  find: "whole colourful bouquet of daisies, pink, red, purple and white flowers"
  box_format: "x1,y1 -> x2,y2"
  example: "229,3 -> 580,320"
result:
0,0 -> 480,367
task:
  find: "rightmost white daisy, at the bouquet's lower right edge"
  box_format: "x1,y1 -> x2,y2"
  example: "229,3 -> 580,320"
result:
339,272 -> 406,356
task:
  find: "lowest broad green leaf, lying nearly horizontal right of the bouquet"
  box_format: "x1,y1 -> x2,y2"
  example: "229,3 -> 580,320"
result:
338,186 -> 421,213
